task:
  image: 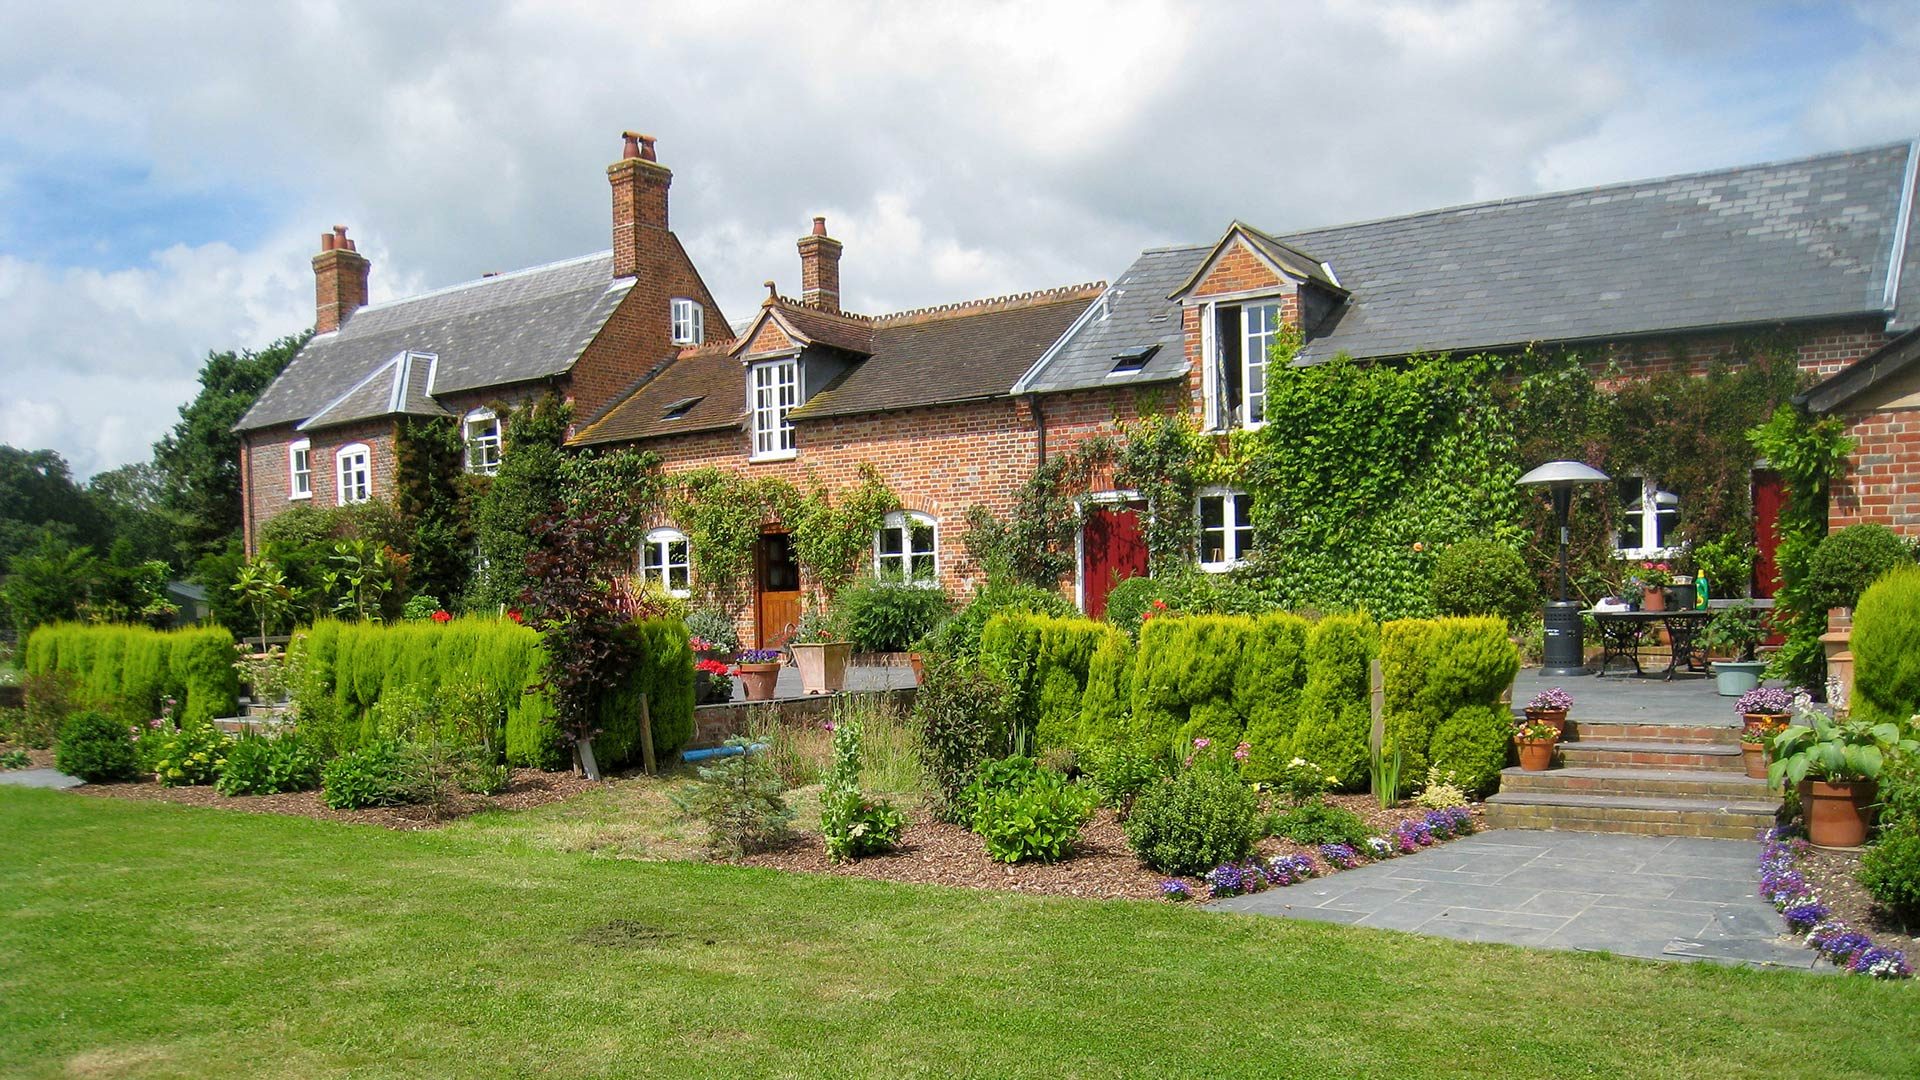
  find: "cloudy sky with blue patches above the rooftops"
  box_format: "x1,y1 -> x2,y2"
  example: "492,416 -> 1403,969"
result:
0,0 -> 1920,477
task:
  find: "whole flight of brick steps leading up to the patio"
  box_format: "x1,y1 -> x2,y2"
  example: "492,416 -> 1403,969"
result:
1486,723 -> 1780,840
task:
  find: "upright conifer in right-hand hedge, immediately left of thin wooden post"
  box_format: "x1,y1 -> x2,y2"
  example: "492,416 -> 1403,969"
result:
1290,615 -> 1380,788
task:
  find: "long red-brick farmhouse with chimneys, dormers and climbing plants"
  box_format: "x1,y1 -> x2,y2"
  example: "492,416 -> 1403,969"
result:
238,135 -> 1920,644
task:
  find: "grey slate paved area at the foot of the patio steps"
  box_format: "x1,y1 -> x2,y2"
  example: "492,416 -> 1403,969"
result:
1210,830 -> 1824,970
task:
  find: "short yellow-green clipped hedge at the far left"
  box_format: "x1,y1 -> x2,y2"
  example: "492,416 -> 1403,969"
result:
27,623 -> 240,723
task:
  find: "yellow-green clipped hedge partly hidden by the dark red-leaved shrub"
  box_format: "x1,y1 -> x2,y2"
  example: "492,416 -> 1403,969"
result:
292,617 -> 693,769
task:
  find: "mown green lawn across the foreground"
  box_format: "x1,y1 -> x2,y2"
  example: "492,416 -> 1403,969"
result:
0,788 -> 1920,1080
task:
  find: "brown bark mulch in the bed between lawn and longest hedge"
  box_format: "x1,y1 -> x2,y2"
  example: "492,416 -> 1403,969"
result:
741,796 -> 1480,899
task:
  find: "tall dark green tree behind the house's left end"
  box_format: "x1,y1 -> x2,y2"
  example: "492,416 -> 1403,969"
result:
154,334 -> 307,565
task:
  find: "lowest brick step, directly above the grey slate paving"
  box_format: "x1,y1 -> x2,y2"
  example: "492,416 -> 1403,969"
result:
1486,792 -> 1778,840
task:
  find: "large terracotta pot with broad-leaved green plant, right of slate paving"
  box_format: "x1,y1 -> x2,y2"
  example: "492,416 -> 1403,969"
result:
1766,713 -> 1920,847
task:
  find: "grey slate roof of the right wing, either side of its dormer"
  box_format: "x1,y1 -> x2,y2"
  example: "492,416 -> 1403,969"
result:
1021,142 -> 1920,392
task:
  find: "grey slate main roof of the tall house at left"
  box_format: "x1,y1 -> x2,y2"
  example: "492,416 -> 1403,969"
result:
234,252 -> 634,430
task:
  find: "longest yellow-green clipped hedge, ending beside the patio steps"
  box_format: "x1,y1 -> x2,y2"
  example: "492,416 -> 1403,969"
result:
981,613 -> 1519,790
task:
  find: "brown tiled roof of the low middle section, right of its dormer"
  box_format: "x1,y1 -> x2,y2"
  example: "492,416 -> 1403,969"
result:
791,282 -> 1104,421
